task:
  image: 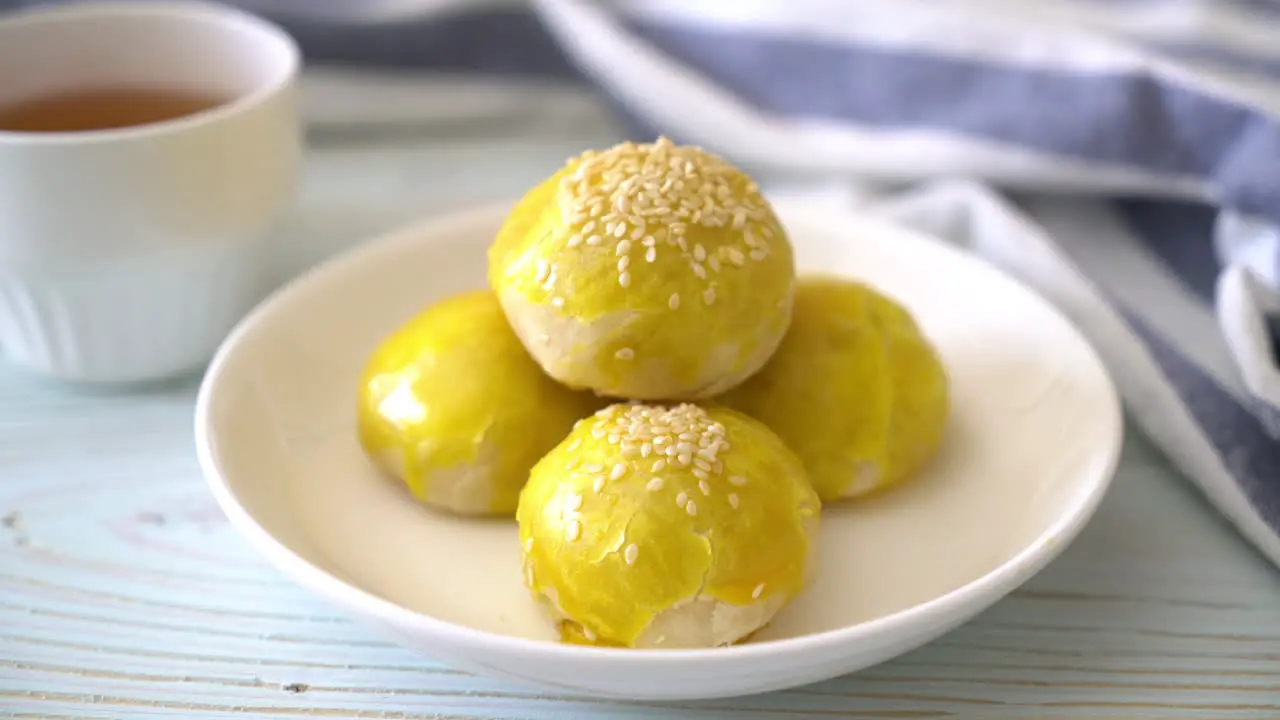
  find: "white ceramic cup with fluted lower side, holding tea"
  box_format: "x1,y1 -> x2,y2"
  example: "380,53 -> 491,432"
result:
0,1 -> 302,383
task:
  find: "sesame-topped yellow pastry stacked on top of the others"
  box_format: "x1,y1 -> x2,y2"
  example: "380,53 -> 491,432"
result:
489,138 -> 795,401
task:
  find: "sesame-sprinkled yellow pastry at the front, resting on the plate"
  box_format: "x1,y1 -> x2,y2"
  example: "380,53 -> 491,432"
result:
516,404 -> 820,648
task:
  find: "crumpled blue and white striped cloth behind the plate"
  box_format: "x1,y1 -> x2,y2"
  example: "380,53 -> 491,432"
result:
17,0 -> 1280,564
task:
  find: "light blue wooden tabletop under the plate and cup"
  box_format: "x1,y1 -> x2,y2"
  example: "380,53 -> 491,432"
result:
0,114 -> 1280,720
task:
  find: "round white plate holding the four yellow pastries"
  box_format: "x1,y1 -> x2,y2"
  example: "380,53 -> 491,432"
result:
196,198 -> 1121,700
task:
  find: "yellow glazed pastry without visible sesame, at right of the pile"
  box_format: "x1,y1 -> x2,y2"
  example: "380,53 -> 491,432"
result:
719,277 -> 950,502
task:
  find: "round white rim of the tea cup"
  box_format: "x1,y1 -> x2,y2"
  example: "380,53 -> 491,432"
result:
0,0 -> 302,146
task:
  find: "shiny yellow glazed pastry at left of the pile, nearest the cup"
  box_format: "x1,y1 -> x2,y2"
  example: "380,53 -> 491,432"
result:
358,291 -> 602,515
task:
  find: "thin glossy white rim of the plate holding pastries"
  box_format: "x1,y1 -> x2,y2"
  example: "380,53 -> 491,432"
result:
195,201 -> 1125,667
